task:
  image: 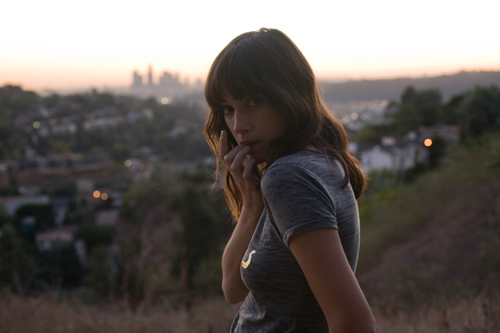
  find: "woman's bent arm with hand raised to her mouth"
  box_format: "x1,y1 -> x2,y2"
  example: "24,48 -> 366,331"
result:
219,131 -> 264,304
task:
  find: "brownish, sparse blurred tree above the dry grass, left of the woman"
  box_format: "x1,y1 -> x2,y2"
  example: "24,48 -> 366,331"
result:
116,174 -> 178,311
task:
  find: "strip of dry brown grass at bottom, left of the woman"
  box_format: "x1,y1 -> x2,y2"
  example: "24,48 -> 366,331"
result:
0,294 -> 236,333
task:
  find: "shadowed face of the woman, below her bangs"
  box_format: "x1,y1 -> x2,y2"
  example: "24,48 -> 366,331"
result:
222,93 -> 286,163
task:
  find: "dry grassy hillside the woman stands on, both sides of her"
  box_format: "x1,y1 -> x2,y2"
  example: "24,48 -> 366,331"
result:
0,137 -> 500,333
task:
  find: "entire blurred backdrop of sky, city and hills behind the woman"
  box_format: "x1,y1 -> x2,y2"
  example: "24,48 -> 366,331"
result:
0,0 -> 500,333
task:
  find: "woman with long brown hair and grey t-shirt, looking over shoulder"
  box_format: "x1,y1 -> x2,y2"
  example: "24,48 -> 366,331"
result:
205,28 -> 375,333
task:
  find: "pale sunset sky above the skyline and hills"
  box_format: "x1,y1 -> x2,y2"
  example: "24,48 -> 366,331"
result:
0,0 -> 500,90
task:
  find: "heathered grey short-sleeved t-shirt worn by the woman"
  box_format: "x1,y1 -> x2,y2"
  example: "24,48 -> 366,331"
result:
231,150 -> 359,333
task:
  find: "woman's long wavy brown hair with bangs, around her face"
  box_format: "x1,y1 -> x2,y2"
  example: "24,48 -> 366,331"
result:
204,28 -> 366,220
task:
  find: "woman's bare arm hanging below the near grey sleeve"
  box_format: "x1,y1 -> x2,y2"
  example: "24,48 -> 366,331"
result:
289,228 -> 376,333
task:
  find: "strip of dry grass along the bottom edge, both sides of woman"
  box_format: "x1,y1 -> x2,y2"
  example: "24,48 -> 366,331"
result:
0,292 -> 500,333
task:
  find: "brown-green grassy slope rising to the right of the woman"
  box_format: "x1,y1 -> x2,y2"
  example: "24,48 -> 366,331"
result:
357,139 -> 500,332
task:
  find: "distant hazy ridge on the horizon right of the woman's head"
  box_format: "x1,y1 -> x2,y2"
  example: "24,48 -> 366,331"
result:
320,72 -> 500,102
